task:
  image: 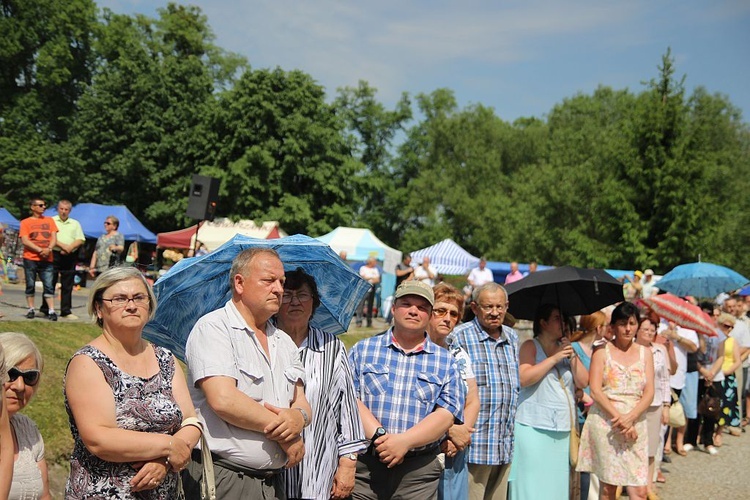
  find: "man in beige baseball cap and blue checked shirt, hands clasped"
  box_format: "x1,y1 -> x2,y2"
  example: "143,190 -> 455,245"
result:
349,280 -> 466,500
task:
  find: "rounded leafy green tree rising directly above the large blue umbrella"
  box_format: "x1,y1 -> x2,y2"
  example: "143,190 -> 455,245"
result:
203,68 -> 359,235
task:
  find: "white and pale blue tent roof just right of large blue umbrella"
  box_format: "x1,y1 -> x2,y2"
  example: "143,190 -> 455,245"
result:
317,227 -> 401,274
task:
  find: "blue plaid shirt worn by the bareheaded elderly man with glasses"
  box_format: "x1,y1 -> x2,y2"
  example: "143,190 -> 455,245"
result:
451,318 -> 521,465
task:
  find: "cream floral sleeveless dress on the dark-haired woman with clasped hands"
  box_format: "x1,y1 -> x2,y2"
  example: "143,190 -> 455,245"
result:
577,343 -> 648,486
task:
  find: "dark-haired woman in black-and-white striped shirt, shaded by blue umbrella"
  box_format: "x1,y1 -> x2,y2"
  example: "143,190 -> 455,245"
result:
276,268 -> 367,500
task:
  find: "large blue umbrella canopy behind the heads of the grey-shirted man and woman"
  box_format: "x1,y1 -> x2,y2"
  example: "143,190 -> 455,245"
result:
143,234 -> 370,360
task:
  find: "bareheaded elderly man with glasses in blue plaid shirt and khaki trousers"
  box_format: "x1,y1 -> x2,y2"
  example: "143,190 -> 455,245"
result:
452,283 -> 520,500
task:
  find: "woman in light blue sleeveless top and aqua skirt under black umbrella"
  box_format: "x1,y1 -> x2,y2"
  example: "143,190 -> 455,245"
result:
509,304 -> 589,499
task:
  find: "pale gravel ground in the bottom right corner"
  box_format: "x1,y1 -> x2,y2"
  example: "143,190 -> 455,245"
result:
659,428 -> 750,500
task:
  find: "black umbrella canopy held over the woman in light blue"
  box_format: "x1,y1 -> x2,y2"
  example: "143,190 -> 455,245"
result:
505,266 -> 623,319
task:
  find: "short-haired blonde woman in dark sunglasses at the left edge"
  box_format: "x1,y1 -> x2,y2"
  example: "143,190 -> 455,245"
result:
0,332 -> 52,500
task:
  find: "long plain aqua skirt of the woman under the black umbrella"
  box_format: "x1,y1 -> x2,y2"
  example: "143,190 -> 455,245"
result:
508,422 -> 570,500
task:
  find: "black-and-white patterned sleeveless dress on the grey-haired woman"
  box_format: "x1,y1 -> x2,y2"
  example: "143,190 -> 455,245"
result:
63,345 -> 182,500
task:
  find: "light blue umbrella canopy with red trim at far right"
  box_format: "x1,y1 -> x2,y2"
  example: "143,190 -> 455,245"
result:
656,262 -> 750,297
